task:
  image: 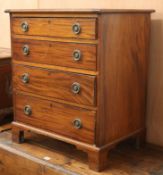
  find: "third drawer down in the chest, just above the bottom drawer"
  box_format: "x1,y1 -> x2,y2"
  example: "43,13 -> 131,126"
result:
13,65 -> 96,105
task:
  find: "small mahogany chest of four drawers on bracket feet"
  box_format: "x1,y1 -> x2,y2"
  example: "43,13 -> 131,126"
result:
8,10 -> 152,171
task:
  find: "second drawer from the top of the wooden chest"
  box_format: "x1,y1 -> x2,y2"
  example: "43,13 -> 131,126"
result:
12,39 -> 96,70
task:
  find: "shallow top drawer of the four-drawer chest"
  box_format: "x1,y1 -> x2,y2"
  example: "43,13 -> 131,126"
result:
11,18 -> 96,39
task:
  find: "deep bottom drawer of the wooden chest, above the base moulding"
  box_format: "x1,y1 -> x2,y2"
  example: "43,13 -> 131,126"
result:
14,93 -> 96,144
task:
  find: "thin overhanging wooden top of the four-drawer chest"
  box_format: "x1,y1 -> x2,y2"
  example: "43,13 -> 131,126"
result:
5,9 -> 155,13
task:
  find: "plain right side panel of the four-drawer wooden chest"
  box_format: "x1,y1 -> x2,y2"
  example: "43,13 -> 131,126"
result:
96,14 -> 150,146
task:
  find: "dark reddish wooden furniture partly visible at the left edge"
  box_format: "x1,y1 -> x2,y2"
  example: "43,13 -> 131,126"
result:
0,48 -> 12,123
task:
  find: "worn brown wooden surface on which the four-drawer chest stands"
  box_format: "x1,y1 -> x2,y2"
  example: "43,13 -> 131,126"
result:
0,132 -> 163,175
